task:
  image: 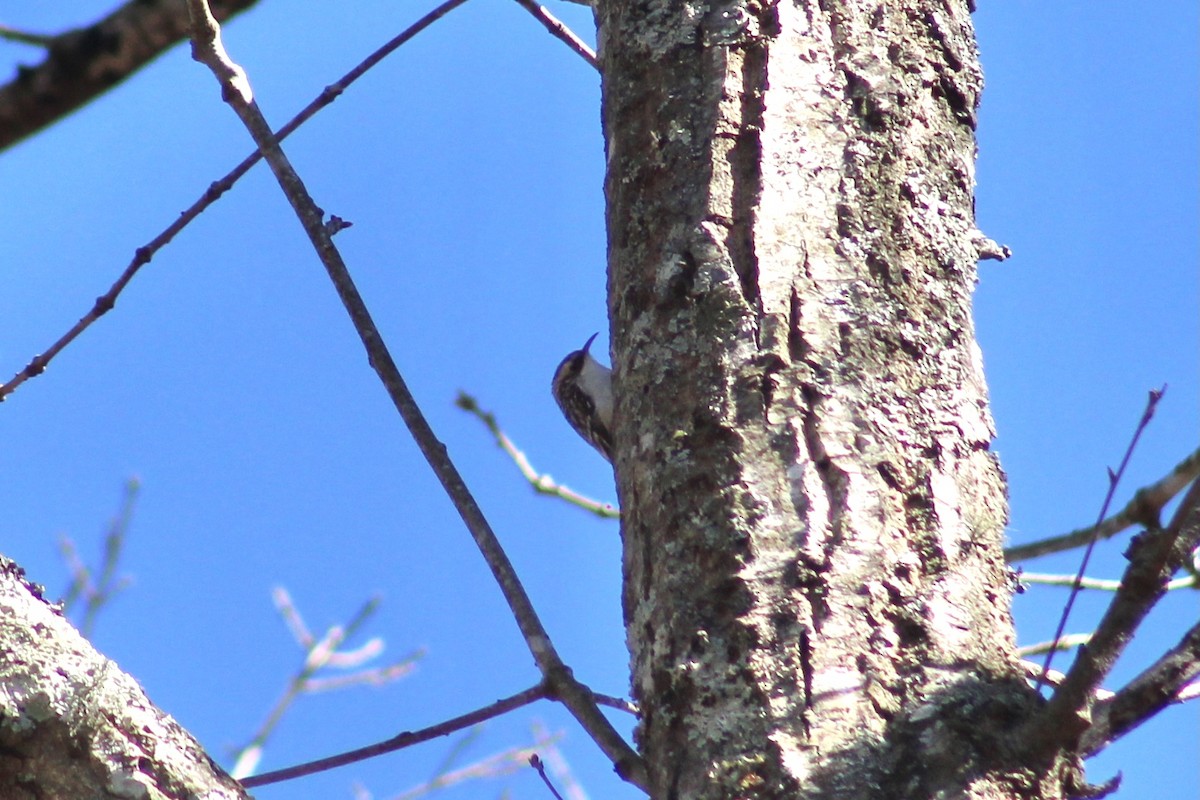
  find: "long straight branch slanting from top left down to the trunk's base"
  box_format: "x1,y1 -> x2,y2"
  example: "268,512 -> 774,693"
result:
188,0 -> 647,789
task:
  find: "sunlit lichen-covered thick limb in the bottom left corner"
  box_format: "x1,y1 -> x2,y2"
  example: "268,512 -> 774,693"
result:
0,557 -> 248,800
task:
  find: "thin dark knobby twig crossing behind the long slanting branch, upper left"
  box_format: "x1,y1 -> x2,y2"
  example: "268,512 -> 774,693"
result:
0,0 -> 467,402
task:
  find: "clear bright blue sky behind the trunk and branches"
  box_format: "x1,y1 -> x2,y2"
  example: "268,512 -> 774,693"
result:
0,0 -> 1200,800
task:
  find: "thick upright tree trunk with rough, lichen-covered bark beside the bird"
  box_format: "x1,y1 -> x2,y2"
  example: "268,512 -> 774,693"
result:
596,0 -> 1078,800
